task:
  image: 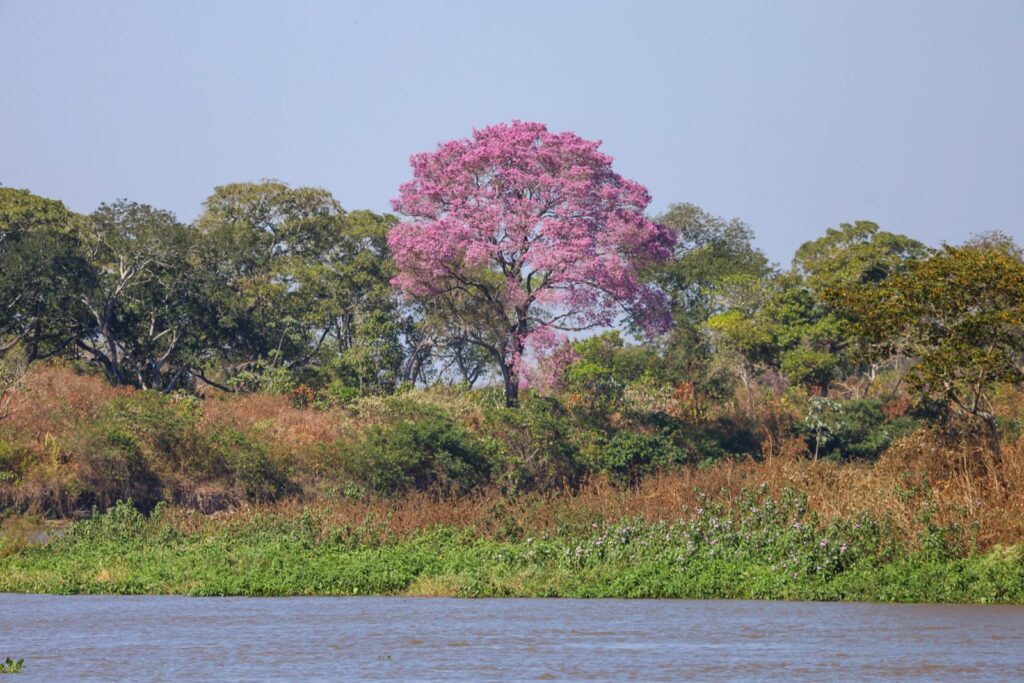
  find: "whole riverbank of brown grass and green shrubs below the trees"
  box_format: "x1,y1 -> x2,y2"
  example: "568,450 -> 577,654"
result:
0,366 -> 1024,603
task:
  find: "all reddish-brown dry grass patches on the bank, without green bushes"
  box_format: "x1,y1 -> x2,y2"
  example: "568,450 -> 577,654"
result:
0,367 -> 1024,548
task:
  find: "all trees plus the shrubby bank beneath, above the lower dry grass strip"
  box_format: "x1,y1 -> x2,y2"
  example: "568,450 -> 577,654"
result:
0,122 -> 1024,528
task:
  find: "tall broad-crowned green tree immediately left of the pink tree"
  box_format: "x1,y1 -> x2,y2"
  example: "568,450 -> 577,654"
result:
197,180 -> 403,393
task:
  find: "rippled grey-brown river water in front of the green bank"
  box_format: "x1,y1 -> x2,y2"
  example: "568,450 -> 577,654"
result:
0,594 -> 1024,682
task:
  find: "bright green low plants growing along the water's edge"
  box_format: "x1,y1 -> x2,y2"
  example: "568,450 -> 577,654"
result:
0,489 -> 1024,603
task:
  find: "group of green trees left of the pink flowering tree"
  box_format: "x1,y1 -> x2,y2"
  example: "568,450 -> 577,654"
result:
0,181 -> 413,394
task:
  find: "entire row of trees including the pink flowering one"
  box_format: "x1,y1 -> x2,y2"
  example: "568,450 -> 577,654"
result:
0,122 -> 1024,462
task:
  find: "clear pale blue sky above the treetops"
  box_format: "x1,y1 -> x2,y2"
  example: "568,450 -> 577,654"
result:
0,0 -> 1024,263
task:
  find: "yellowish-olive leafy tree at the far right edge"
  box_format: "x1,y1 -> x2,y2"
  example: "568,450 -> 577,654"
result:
833,245 -> 1024,446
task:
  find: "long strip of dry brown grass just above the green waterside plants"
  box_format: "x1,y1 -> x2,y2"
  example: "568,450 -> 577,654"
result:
157,433 -> 1024,550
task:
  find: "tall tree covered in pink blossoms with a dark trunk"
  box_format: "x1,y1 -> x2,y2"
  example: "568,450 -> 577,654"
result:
388,121 -> 674,408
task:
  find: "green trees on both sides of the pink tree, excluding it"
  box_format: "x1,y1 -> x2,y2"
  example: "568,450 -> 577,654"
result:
0,180 -> 1024,483
